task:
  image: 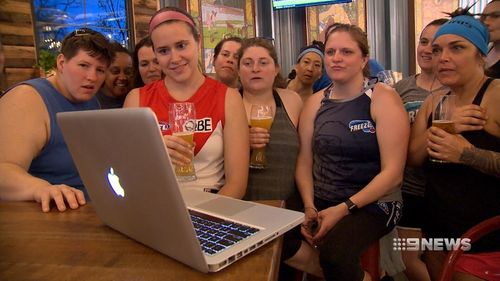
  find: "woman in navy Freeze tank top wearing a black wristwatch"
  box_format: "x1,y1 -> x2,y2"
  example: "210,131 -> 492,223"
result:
286,24 -> 409,281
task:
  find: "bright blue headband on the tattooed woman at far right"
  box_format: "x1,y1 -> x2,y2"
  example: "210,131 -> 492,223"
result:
434,15 -> 490,55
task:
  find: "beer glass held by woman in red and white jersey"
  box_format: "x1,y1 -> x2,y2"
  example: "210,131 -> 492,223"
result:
168,102 -> 196,181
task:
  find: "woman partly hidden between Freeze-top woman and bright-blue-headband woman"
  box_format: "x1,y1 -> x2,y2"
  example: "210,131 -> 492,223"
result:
394,19 -> 448,281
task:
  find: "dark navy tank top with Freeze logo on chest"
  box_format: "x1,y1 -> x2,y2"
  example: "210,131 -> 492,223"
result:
313,81 -> 380,202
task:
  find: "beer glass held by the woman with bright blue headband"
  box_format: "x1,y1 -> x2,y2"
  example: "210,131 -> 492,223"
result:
430,95 -> 456,163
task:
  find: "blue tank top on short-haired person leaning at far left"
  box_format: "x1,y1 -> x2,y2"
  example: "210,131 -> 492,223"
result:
21,78 -> 99,194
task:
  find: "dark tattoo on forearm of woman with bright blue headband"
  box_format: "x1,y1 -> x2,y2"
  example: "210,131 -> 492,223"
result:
460,147 -> 500,177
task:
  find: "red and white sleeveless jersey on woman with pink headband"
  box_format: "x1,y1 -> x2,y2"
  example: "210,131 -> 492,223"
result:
139,77 -> 227,189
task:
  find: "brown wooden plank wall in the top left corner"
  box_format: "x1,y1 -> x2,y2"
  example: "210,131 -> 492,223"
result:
0,0 -> 39,88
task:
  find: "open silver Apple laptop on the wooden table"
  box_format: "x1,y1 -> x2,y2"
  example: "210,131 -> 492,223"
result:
57,108 -> 304,272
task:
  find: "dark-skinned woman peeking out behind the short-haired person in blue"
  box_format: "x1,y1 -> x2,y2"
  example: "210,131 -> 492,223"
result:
97,42 -> 134,109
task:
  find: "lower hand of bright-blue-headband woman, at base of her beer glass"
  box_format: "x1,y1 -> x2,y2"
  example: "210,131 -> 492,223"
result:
427,127 -> 472,163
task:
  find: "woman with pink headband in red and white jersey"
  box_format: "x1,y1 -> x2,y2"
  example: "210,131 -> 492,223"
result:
125,7 -> 249,198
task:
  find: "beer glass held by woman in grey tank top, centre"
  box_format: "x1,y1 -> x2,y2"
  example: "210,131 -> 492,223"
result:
250,104 -> 273,169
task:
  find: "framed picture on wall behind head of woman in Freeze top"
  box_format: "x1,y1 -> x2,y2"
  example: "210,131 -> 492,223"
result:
306,0 -> 366,44
